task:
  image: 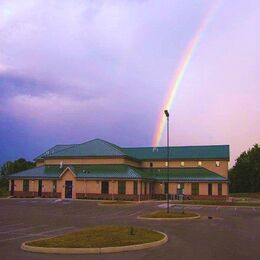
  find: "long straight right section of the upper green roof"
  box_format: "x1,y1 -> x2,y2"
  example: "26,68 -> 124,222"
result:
122,145 -> 229,160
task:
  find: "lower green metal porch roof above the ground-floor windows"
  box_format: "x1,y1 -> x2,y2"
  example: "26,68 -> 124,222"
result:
9,165 -> 227,182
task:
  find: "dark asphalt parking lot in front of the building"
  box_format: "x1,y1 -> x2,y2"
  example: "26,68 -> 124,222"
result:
0,199 -> 260,259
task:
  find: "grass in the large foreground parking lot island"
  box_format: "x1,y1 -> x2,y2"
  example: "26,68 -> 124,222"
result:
27,225 -> 164,248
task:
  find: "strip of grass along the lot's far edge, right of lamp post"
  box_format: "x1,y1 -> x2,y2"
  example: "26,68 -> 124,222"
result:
172,200 -> 260,207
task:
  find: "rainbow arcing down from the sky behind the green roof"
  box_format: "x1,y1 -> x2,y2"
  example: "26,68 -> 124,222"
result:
152,1 -> 220,147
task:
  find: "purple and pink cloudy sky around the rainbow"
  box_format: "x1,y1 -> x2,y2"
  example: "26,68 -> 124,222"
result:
0,0 -> 260,165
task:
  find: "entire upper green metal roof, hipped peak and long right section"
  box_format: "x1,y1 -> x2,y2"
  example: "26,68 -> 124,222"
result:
36,139 -> 229,160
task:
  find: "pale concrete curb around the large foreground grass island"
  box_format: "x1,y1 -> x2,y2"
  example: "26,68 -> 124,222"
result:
21,230 -> 168,254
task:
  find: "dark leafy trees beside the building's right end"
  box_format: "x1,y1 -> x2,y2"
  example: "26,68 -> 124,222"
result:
229,144 -> 260,192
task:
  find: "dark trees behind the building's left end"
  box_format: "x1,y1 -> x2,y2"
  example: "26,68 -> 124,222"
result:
0,158 -> 35,189
